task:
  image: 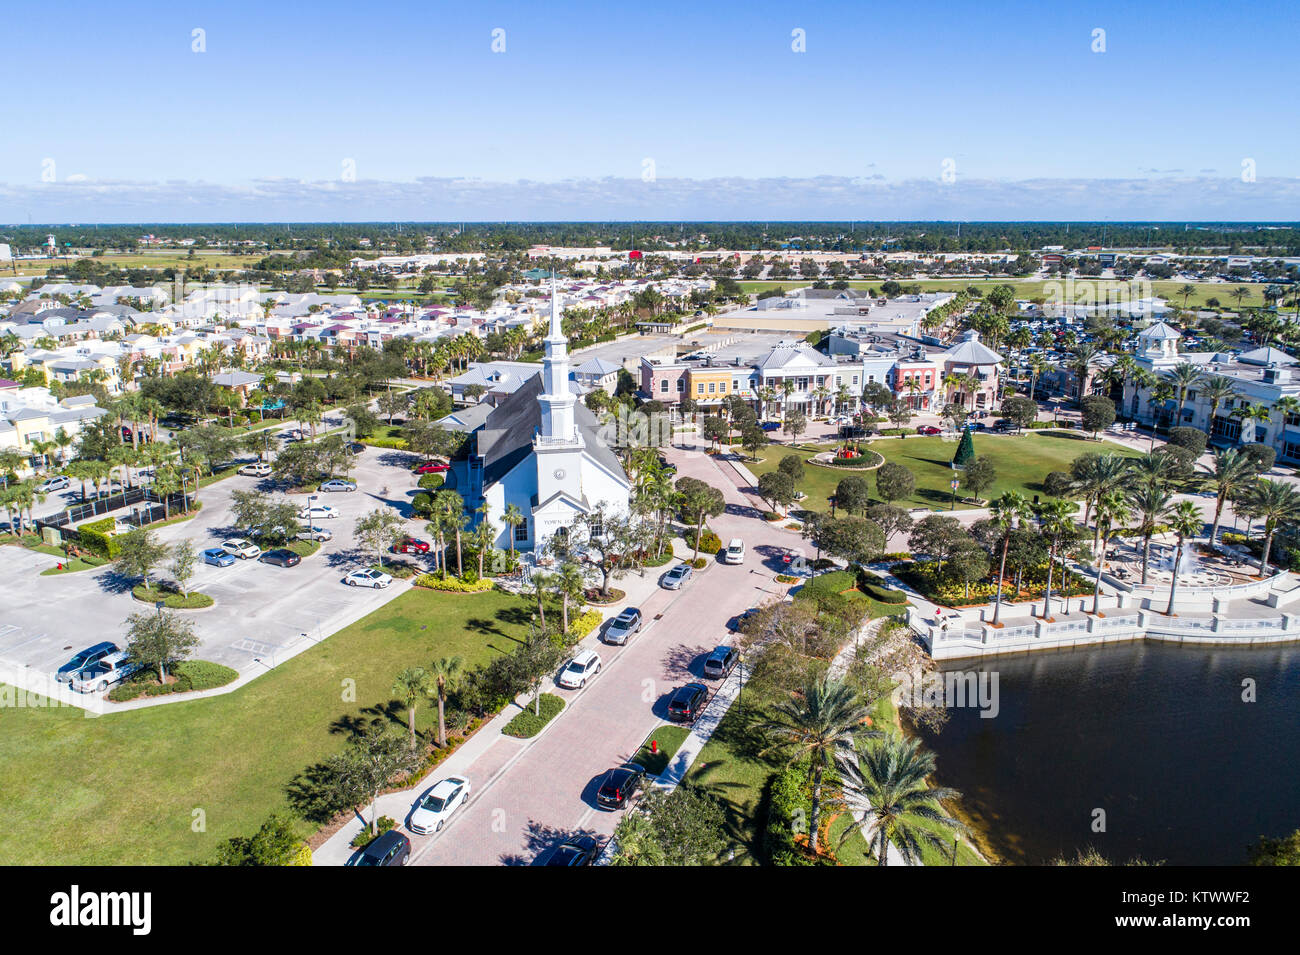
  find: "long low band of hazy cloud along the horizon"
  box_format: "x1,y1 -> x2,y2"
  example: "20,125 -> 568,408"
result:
0,170 -> 1300,222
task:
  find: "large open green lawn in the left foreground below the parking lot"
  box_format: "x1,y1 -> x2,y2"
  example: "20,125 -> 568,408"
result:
0,590 -> 529,865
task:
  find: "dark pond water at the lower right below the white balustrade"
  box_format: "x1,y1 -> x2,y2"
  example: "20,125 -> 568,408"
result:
922,643 -> 1300,865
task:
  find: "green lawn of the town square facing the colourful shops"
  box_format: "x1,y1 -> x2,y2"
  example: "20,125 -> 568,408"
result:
745,430 -> 1140,511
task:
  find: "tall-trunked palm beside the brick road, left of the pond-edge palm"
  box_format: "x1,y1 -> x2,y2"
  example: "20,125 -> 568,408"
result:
758,673 -> 871,854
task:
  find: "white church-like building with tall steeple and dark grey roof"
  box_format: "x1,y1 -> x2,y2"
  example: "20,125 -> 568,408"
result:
447,282 -> 631,551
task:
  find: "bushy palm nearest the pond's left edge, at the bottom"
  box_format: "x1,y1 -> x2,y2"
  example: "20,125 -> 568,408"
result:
837,734 -> 966,865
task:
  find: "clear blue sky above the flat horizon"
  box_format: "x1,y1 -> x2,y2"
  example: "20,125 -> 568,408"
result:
0,0 -> 1300,221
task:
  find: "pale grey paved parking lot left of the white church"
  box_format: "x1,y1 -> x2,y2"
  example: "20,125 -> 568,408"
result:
0,436 -> 436,691
